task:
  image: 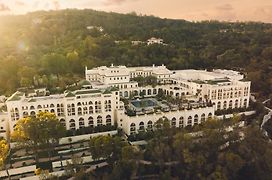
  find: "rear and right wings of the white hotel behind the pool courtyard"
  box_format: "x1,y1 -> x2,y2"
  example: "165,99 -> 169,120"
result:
85,65 -> 251,110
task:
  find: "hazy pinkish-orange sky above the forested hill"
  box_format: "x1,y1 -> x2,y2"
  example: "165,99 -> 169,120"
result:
0,0 -> 272,22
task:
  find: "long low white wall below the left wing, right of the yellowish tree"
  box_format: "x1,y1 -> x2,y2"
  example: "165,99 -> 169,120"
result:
59,130 -> 117,145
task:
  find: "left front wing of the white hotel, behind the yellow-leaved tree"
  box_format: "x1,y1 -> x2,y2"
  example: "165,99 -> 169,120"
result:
6,89 -> 123,132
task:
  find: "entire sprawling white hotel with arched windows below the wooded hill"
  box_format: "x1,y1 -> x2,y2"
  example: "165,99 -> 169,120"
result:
3,65 -> 250,135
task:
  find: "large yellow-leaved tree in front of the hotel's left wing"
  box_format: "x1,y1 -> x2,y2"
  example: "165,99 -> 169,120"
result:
11,112 -> 65,162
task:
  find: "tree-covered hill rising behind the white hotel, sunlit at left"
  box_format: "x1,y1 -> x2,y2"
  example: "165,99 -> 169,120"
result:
0,10 -> 272,96
